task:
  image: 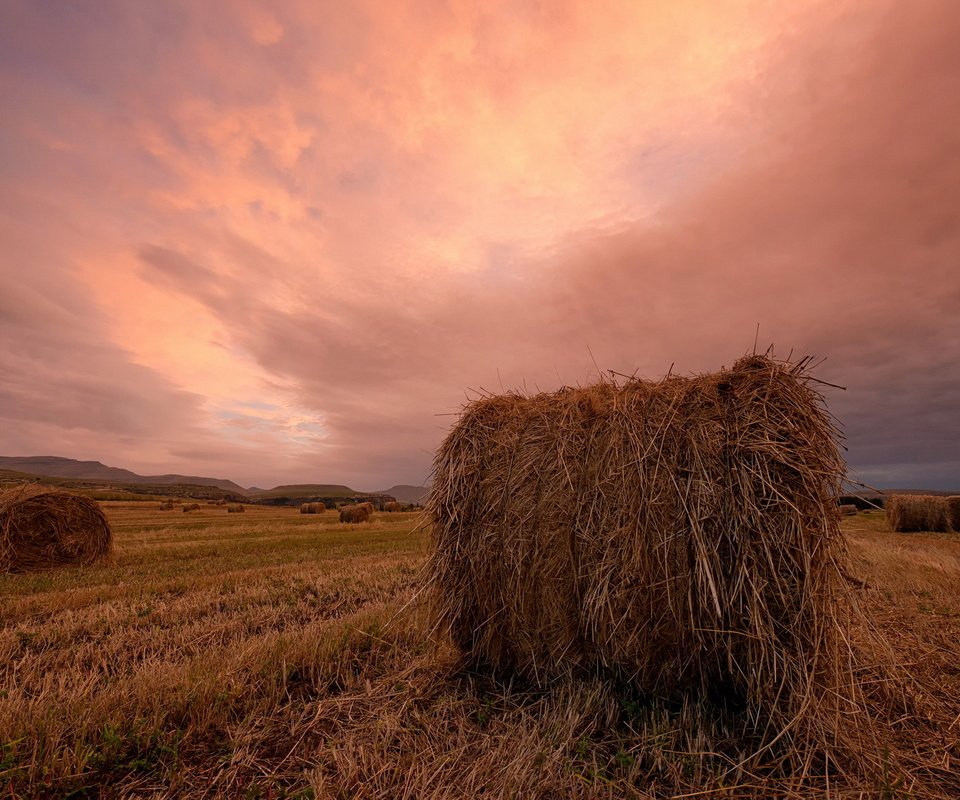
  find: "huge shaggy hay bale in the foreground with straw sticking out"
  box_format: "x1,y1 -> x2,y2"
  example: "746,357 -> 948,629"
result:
426,356 -> 860,764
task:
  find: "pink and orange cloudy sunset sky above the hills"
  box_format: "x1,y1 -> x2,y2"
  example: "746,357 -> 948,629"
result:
0,0 -> 960,489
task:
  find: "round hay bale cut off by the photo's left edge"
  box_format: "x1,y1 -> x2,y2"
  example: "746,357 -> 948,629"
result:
0,485 -> 113,572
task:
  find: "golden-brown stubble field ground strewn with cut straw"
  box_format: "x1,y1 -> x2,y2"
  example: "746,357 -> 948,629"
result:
0,502 -> 960,800
